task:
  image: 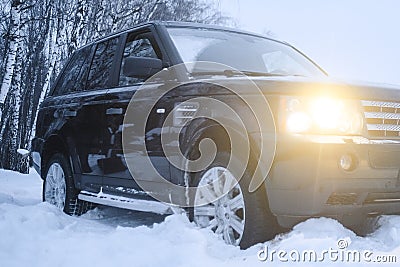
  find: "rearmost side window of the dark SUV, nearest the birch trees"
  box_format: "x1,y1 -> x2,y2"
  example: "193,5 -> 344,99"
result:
53,47 -> 91,96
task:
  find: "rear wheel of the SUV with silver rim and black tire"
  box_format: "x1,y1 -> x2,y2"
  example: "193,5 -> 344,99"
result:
42,153 -> 92,216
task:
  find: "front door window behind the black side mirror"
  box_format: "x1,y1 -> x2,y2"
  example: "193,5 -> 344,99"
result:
119,33 -> 161,86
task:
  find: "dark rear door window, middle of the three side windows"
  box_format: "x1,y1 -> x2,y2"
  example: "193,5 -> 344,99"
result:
86,38 -> 118,90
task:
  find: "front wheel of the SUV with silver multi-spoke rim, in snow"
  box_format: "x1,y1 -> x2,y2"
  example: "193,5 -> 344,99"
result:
188,152 -> 282,249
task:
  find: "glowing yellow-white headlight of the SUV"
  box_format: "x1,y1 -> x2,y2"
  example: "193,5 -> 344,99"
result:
280,97 -> 363,135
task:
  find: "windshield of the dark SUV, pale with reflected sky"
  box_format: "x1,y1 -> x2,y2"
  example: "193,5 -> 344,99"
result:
168,27 -> 325,77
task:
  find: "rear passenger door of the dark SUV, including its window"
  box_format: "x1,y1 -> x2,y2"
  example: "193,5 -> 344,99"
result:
75,36 -> 120,192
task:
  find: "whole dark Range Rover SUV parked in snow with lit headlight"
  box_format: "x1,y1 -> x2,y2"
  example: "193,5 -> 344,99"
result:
31,22 -> 400,247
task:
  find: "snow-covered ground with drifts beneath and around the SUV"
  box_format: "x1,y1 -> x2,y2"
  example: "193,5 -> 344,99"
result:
0,170 -> 400,267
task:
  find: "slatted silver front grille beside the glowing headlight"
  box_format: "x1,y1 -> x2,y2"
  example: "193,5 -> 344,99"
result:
361,100 -> 400,138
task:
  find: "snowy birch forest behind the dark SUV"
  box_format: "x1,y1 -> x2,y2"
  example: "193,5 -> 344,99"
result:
0,0 -> 227,172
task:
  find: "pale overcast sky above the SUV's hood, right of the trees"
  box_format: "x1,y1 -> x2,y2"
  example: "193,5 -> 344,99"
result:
219,0 -> 400,85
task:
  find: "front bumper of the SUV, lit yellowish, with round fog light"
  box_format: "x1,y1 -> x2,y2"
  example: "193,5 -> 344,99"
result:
266,136 -> 400,227
